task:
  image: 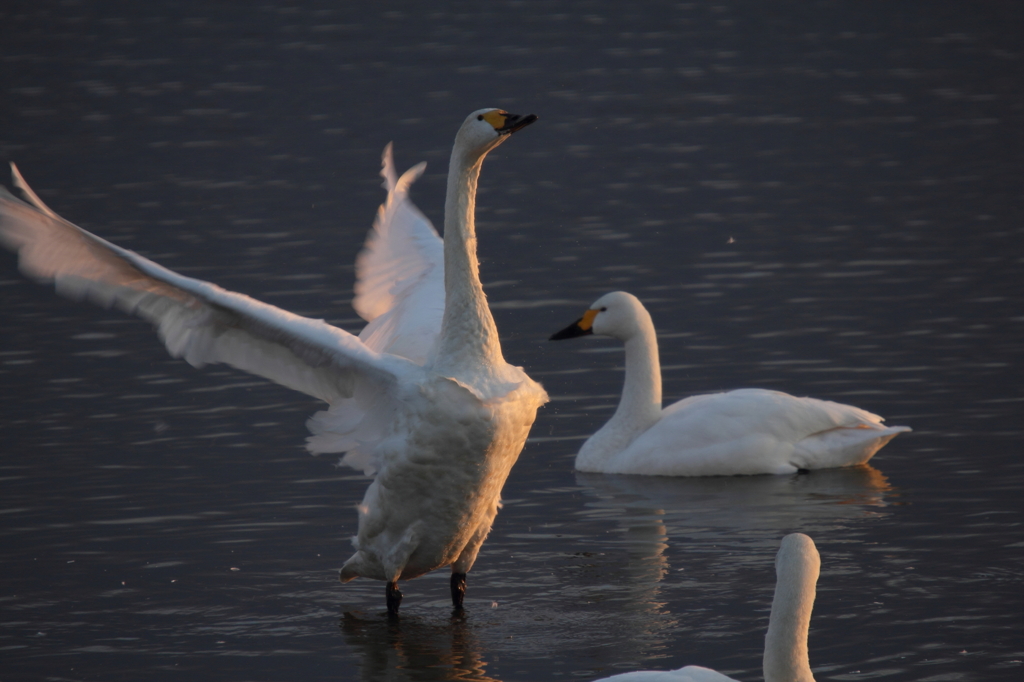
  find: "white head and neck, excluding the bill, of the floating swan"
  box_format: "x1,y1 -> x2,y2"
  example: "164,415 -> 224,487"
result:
577,291 -> 662,471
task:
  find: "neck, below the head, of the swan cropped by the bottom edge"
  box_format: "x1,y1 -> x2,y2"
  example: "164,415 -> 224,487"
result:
764,550 -> 819,682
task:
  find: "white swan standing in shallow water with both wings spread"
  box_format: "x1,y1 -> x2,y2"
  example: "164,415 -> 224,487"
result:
0,109 -> 547,613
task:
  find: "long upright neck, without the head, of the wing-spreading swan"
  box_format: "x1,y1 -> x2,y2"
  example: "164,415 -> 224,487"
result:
434,144 -> 504,379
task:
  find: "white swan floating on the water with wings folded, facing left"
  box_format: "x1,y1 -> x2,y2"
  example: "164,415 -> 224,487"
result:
551,291 -> 910,476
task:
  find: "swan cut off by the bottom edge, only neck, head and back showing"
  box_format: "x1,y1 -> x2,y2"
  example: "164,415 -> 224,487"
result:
596,532 -> 821,682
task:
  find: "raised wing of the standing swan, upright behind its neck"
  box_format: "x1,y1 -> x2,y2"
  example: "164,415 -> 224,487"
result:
352,143 -> 444,365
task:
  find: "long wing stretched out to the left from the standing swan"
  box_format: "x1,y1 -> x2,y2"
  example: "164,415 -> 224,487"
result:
0,163 -> 421,452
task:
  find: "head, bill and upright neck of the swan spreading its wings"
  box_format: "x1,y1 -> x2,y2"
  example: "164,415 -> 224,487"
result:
433,110 -> 536,383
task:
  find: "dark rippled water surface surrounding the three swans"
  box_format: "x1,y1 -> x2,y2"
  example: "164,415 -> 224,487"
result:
0,0 -> 1024,682
